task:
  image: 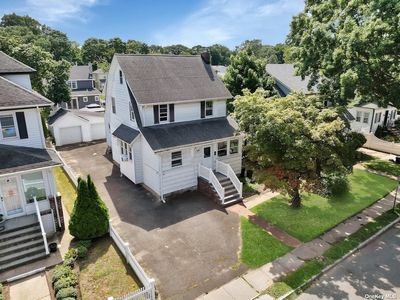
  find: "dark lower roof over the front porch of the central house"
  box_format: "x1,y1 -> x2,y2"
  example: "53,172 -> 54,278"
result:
141,117 -> 238,151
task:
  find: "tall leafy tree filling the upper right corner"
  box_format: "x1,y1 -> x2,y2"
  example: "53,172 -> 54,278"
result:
288,0 -> 400,107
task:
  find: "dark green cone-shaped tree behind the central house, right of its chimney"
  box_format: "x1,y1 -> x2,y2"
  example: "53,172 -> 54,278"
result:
223,49 -> 276,96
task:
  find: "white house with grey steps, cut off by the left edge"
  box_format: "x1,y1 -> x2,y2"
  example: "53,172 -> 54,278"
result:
0,52 -> 62,272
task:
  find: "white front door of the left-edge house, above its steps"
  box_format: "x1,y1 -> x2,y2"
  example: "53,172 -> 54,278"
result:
0,177 -> 24,217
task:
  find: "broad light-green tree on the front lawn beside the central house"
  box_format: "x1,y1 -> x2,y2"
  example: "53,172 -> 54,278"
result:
234,89 -> 365,207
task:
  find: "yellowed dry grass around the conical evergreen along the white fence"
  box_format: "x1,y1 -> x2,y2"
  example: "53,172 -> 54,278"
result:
54,168 -> 141,300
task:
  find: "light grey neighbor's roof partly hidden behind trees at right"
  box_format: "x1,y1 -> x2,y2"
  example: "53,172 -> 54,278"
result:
266,64 -> 316,94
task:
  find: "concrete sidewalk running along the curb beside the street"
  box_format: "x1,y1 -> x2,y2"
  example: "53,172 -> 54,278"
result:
197,191 -> 395,300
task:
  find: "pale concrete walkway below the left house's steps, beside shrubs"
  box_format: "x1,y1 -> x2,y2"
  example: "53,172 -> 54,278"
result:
10,272 -> 51,300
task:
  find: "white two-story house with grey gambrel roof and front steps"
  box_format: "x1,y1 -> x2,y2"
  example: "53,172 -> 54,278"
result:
105,54 -> 243,204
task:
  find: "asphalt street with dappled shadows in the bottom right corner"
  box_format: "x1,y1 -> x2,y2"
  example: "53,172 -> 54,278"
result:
298,224 -> 400,300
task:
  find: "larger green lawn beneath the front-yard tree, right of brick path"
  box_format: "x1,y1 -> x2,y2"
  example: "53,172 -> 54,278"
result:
252,170 -> 397,242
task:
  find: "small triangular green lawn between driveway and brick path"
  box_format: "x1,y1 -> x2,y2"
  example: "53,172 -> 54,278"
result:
240,217 -> 292,268
